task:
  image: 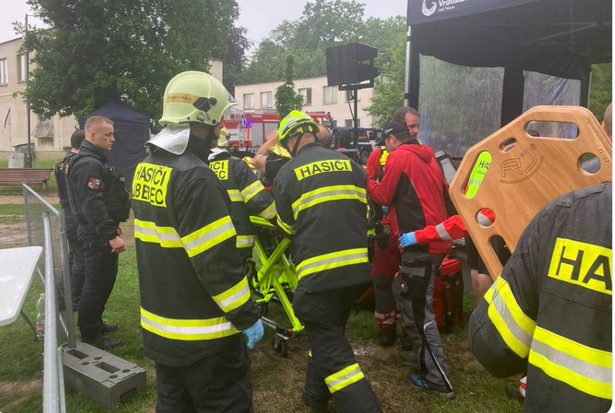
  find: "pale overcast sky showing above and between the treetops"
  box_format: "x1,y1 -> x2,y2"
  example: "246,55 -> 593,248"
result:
0,0 -> 407,48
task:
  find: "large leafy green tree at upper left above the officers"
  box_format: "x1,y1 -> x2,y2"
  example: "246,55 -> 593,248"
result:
19,0 -> 238,118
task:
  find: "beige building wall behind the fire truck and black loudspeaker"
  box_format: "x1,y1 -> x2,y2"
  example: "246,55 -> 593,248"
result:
235,76 -> 376,128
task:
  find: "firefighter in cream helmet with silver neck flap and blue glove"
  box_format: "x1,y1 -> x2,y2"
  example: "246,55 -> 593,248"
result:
132,71 -> 263,412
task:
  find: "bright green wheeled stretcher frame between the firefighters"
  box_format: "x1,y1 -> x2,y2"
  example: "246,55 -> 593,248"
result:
246,216 -> 304,356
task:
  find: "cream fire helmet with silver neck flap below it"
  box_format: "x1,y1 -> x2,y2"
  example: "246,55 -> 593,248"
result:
159,71 -> 237,126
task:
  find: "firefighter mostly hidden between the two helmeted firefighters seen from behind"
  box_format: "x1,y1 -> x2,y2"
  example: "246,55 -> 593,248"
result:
209,127 -> 276,262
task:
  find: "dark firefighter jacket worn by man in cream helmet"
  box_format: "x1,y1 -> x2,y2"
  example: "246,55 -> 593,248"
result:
132,138 -> 259,366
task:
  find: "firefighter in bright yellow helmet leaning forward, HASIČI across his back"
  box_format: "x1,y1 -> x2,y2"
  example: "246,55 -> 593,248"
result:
274,110 -> 381,412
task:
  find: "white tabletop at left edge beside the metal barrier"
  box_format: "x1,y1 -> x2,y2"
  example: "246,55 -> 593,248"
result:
0,247 -> 43,326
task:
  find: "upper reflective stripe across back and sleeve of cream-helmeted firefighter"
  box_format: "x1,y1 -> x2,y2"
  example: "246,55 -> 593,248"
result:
135,215 -> 236,258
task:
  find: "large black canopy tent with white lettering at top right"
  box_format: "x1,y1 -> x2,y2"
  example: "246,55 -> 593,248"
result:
405,0 -> 612,125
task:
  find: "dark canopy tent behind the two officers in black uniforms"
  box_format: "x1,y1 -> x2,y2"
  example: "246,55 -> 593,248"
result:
79,98 -> 150,189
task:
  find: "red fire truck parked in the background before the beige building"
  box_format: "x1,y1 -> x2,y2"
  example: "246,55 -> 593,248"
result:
222,109 -> 333,149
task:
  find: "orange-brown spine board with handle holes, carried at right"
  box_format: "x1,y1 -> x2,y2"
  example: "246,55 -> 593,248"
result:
450,106 -> 612,280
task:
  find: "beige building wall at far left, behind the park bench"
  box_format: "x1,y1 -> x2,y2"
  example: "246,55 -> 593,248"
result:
0,38 -> 78,159
